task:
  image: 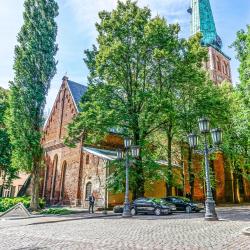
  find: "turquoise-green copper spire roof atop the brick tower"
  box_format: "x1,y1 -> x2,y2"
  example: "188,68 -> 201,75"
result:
188,0 -> 222,50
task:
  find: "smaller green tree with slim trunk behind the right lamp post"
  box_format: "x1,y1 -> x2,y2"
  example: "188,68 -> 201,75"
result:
175,75 -> 229,197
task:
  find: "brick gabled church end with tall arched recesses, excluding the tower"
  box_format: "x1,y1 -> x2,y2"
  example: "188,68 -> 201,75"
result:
42,77 -> 127,206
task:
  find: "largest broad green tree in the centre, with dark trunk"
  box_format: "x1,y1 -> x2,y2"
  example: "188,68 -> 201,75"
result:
68,1 -> 183,196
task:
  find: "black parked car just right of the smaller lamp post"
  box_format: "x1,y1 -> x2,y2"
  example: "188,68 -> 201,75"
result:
131,198 -> 176,216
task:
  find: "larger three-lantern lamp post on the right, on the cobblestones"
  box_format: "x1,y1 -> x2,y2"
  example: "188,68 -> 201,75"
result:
188,118 -> 222,220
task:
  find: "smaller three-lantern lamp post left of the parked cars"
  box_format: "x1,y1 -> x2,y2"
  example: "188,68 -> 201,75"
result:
117,138 -> 140,218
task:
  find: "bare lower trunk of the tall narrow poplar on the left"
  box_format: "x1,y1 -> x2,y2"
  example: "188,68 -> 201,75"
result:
30,161 -> 40,211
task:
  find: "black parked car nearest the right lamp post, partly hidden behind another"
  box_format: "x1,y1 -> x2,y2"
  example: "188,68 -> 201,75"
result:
163,196 -> 204,213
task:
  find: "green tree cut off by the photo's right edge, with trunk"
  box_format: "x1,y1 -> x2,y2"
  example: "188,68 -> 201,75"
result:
224,25 -> 250,203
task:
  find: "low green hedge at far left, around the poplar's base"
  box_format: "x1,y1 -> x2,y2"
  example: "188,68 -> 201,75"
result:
0,197 -> 45,212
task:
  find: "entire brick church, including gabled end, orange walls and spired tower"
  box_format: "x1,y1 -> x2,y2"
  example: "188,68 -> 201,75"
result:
41,0 -> 250,207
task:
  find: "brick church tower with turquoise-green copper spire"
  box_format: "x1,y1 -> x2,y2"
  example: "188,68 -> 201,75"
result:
188,0 -> 232,85
